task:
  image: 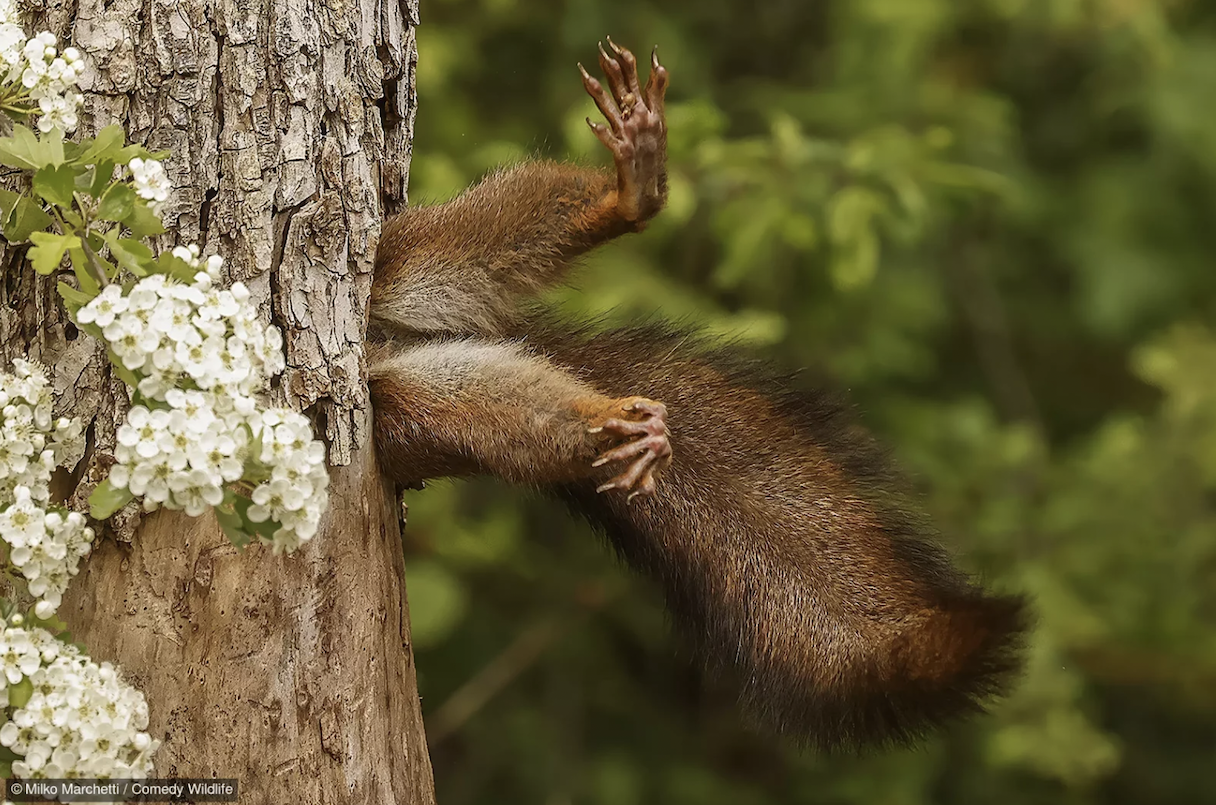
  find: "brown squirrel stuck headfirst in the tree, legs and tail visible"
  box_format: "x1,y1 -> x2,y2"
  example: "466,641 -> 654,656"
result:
368,40 -> 1025,748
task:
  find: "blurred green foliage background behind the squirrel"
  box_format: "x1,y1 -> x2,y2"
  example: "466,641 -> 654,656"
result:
406,0 -> 1216,805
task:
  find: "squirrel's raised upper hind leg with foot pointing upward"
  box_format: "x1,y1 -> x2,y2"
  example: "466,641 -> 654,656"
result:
371,43 -> 668,336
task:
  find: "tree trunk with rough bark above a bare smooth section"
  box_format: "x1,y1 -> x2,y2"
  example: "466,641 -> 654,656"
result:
0,0 -> 434,805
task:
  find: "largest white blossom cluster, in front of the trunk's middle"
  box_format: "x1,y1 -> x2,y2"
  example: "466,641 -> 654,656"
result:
77,246 -> 328,552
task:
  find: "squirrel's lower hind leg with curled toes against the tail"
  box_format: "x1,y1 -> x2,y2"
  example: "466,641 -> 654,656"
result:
368,338 -> 671,497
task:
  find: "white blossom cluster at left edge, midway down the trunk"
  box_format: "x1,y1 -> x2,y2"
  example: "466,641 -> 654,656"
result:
0,360 -> 94,618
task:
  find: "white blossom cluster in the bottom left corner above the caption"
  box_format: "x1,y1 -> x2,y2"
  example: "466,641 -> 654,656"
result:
0,626 -> 159,779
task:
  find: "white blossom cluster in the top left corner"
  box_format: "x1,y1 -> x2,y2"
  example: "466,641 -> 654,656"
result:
0,0 -> 84,131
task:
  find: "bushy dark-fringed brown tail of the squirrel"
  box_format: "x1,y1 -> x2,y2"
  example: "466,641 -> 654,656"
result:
528,327 -> 1028,749
